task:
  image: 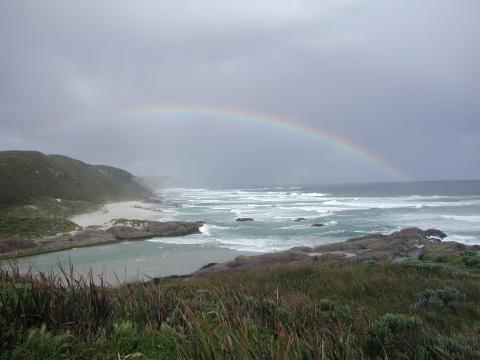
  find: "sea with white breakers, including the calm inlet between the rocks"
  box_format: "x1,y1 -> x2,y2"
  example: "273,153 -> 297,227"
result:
7,181 -> 480,281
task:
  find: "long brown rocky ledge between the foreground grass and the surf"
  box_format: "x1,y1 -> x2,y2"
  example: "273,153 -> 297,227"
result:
183,228 -> 480,278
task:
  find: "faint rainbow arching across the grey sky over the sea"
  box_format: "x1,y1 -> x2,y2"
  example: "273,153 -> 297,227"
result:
81,105 -> 410,181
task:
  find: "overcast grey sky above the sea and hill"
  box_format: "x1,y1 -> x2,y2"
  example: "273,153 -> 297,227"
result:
0,0 -> 480,185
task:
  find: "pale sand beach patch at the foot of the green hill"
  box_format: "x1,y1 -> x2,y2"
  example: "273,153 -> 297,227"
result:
70,201 -> 162,227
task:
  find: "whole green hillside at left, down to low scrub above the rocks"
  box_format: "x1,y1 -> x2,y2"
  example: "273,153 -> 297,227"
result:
0,151 -> 150,239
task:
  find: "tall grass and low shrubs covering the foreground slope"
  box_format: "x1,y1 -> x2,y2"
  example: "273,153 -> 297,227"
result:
0,253 -> 480,359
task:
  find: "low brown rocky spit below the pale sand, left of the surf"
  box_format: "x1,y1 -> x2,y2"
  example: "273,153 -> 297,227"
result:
0,219 -> 203,258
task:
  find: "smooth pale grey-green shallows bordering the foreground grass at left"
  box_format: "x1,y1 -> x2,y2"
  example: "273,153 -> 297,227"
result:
6,245 -> 257,285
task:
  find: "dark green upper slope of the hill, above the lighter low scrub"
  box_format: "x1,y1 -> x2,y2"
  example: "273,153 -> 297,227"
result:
0,151 -> 150,205
